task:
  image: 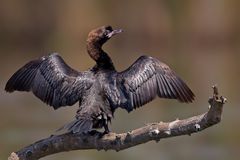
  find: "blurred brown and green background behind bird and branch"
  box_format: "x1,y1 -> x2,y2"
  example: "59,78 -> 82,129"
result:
0,0 -> 240,160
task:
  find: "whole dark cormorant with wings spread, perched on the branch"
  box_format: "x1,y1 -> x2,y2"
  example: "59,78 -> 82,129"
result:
5,25 -> 195,134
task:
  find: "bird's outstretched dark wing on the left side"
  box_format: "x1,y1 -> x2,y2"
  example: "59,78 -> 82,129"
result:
5,53 -> 93,109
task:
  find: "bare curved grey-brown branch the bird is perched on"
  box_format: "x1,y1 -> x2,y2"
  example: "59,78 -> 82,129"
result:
8,86 -> 226,160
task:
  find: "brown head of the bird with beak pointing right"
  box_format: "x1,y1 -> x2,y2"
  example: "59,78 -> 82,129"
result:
87,25 -> 122,45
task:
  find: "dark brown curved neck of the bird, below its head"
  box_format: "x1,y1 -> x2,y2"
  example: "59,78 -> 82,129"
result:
87,42 -> 115,70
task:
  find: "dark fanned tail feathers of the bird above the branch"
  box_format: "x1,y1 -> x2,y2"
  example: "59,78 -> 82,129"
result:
57,119 -> 93,133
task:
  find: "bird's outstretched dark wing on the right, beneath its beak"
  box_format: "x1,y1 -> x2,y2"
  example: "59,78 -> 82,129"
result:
108,56 -> 194,111
